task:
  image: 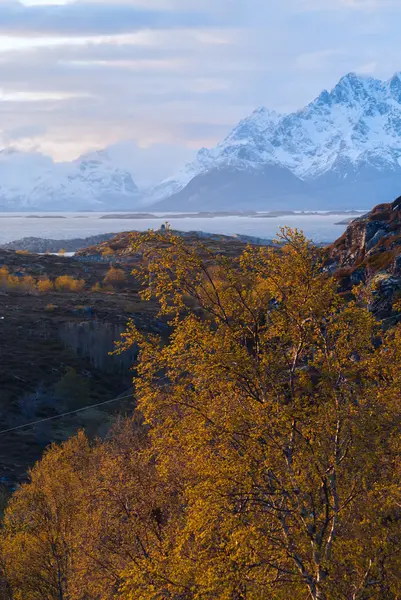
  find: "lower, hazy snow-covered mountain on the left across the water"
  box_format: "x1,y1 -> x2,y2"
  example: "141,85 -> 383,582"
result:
0,148 -> 140,211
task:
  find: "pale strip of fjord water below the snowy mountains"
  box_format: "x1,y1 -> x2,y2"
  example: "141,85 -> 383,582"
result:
0,213 -> 358,244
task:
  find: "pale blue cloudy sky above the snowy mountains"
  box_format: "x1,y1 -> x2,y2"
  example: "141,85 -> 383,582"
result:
0,0 -> 401,183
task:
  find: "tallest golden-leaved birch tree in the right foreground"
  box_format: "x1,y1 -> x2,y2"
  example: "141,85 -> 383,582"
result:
118,230 -> 401,600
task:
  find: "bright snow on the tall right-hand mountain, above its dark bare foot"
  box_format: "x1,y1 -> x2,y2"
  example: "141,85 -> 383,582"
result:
150,73 -> 401,208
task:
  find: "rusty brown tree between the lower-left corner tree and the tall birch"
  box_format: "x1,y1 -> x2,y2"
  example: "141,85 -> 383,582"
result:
69,418 -> 181,600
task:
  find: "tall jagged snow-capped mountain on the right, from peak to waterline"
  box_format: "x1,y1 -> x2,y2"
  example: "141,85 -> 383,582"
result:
152,73 -> 401,210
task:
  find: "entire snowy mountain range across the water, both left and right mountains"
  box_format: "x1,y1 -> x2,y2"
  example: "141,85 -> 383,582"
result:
0,73 -> 401,211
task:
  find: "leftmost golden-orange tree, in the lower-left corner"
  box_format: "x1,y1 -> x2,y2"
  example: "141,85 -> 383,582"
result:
0,434 -> 90,600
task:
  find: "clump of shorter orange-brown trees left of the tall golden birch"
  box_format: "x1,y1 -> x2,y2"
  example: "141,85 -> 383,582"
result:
0,418 -> 181,600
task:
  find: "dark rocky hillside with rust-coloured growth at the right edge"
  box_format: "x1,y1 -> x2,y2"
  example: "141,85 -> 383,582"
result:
327,197 -> 401,318
